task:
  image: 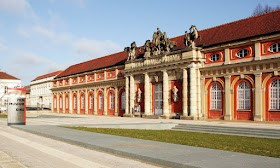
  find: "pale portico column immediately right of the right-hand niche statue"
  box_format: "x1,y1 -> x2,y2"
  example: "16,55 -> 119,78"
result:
182,68 -> 188,116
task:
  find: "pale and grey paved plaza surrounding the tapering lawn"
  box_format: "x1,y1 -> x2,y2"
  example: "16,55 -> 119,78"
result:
0,113 -> 280,167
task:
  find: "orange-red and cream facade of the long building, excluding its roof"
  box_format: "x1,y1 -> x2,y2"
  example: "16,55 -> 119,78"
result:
50,34 -> 280,121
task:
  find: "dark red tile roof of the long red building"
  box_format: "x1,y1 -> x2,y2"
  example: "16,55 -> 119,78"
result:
57,10 -> 280,78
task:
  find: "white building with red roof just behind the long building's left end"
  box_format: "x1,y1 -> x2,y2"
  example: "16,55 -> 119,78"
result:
30,71 -> 62,109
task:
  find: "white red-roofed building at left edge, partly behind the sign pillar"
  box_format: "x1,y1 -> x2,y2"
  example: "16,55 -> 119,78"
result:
0,72 -> 21,111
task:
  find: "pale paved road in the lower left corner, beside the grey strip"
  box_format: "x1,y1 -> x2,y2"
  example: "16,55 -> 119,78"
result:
0,119 -> 160,168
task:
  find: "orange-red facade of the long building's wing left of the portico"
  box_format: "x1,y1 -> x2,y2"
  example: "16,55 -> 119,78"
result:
52,66 -> 125,116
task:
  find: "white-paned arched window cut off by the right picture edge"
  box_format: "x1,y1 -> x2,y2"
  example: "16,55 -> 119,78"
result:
270,79 -> 280,110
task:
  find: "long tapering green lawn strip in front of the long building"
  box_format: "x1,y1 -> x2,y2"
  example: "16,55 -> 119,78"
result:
65,127 -> 280,158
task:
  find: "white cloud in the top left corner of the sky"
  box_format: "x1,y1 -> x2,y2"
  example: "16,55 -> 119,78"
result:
0,0 -> 36,17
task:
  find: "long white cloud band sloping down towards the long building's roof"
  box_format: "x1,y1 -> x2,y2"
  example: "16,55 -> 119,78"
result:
17,25 -> 121,58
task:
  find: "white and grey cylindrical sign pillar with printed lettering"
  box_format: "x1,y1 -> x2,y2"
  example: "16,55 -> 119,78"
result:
7,88 -> 26,125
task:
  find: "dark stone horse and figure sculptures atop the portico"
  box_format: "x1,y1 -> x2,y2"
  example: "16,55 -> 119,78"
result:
124,25 -> 198,61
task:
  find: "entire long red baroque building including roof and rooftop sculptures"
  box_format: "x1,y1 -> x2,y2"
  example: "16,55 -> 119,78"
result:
52,10 -> 280,121
